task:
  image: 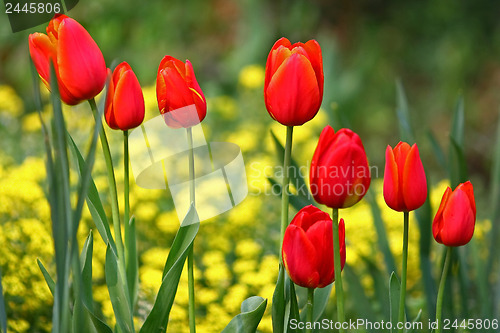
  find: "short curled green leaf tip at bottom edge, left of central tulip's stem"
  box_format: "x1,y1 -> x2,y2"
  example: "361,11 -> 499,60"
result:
222,296 -> 267,333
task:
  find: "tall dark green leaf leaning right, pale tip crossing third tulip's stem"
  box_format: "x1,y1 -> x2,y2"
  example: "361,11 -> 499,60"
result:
140,205 -> 200,333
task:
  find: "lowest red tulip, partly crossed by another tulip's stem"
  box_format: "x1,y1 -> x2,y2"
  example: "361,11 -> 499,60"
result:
282,205 -> 345,288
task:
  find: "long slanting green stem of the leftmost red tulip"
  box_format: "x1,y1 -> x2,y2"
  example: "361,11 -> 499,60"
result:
89,99 -> 124,262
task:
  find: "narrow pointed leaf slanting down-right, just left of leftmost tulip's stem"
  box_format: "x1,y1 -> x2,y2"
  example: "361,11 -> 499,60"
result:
69,136 -> 117,254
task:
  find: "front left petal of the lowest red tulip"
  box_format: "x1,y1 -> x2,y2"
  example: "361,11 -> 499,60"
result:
282,224 -> 320,288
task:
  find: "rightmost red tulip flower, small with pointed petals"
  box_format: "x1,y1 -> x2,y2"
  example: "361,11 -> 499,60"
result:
432,181 -> 476,246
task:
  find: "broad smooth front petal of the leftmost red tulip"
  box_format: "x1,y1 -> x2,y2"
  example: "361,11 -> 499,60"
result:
57,18 -> 106,100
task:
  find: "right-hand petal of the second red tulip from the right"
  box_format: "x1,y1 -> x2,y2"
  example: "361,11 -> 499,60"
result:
398,144 -> 427,211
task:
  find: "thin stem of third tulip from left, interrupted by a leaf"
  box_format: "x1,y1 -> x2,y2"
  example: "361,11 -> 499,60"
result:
186,127 -> 196,333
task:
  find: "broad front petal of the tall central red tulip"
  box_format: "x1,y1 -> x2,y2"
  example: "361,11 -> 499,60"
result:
265,53 -> 321,126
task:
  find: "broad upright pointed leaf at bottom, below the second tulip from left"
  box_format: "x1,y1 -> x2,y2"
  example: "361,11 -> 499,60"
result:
105,244 -> 134,333
